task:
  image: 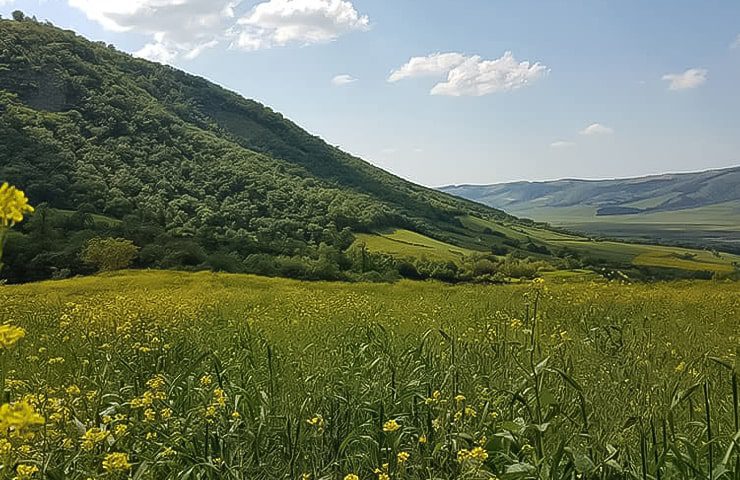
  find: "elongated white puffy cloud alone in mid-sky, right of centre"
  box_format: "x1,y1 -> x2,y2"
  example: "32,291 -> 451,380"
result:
388,52 -> 548,97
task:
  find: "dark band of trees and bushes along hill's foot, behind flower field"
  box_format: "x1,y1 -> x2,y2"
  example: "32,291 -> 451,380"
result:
3,204 -> 563,283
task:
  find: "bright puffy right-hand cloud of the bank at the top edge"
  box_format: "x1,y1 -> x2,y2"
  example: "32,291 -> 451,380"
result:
232,0 -> 370,50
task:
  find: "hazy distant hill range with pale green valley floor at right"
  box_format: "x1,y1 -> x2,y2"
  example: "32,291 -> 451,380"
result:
440,166 -> 740,251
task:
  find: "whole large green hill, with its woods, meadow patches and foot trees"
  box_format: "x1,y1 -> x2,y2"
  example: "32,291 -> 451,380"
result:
0,19 -> 736,282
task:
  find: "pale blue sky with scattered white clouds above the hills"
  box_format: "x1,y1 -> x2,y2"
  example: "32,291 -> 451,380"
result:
0,0 -> 740,186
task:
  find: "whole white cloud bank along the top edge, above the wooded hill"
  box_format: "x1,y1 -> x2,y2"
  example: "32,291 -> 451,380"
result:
66,0 -> 369,63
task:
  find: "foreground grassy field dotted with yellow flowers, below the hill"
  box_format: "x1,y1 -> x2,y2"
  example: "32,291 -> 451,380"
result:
0,271 -> 740,480
